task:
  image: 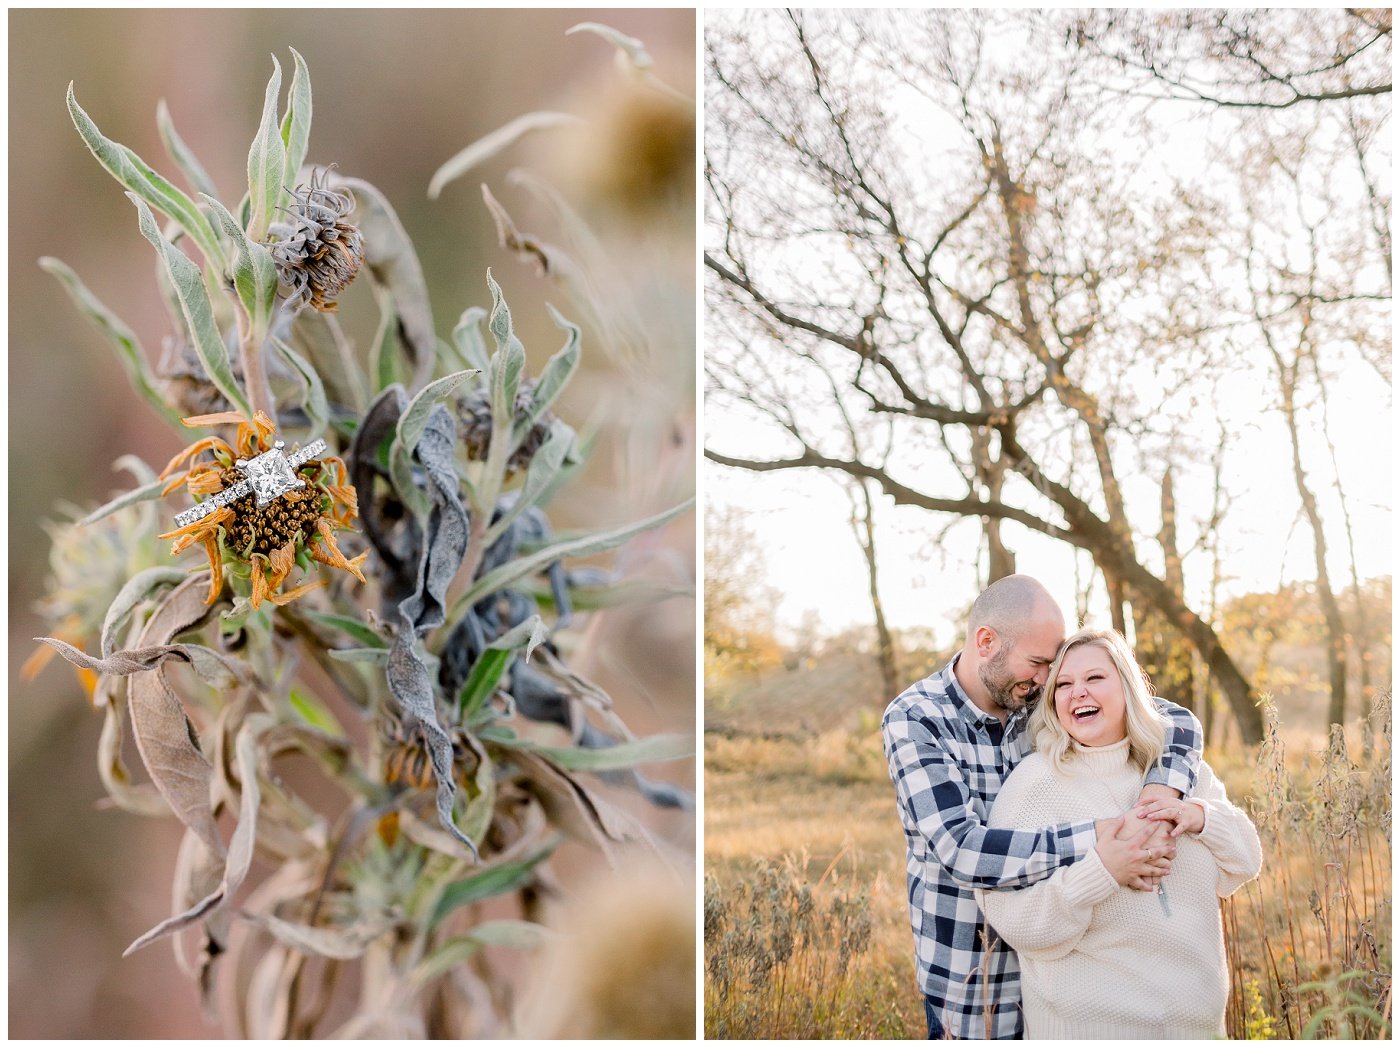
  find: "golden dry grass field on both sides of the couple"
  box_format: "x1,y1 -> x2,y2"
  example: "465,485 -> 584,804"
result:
704,667 -> 1392,1040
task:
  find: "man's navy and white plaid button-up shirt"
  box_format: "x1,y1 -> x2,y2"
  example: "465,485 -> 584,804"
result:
883,655 -> 1201,1040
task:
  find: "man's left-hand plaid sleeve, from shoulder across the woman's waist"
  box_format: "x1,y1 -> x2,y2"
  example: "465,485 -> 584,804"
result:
883,704 -> 1098,887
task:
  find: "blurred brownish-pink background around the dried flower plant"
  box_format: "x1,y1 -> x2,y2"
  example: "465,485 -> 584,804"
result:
10,10 -> 694,1038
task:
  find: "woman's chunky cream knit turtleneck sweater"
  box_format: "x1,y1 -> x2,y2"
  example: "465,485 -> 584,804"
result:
977,739 -> 1261,1038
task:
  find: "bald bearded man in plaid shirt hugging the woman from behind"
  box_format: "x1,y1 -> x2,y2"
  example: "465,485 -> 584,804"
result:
883,575 -> 1201,1040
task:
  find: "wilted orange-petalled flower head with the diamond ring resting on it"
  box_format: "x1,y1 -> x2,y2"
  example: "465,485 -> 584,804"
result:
160,411 -> 368,607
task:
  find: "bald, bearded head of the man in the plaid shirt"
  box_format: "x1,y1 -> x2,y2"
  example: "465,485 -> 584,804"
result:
959,575 -> 1064,712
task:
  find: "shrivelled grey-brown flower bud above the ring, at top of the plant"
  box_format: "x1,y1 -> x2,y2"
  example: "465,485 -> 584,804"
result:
270,172 -> 364,313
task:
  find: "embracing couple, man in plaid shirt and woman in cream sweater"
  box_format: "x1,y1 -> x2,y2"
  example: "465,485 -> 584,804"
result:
883,575 -> 1261,1040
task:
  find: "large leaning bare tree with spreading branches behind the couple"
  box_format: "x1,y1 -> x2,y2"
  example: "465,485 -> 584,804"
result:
706,13 -> 1260,740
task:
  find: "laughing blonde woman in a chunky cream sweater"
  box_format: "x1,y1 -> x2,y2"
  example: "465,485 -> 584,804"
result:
977,630 -> 1261,1038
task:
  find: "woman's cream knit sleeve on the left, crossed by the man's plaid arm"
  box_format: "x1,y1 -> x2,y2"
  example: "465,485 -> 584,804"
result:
974,758 -> 1117,960
